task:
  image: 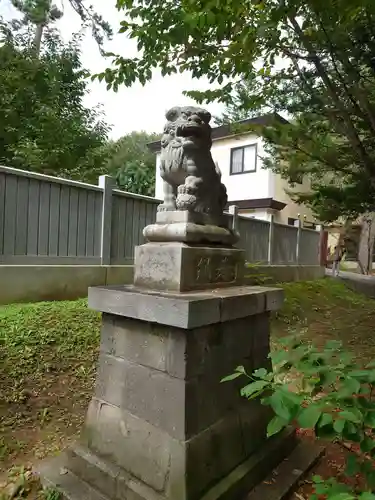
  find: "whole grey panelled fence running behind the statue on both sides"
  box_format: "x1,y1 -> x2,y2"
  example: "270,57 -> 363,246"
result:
0,166 -> 320,265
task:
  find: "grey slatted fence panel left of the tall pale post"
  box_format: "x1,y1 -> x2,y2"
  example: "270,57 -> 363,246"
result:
0,167 -> 102,264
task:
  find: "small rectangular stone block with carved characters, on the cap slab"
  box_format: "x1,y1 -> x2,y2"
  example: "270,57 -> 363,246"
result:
134,243 -> 245,292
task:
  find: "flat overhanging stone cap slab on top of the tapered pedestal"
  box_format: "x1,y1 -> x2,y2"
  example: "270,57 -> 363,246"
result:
89,286 -> 283,329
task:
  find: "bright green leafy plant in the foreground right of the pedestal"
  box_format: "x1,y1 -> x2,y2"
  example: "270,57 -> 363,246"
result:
222,337 -> 375,500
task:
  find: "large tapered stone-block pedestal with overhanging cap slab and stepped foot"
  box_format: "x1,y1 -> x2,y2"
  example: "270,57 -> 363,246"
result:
36,286 -> 295,500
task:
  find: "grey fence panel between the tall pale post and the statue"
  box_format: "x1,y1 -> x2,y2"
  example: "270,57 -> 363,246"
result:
111,190 -> 160,264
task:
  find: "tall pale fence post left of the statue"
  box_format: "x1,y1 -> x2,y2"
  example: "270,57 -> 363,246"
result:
99,175 -> 114,266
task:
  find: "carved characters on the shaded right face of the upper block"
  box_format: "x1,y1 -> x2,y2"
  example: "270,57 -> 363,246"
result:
195,255 -> 238,284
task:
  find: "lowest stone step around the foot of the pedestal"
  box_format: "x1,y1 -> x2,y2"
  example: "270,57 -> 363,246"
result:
36,430 -> 298,500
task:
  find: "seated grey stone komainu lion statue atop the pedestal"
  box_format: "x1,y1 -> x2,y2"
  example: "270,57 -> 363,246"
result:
158,106 -> 228,215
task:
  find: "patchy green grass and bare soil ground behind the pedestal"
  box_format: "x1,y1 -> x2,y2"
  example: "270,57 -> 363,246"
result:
0,279 -> 375,500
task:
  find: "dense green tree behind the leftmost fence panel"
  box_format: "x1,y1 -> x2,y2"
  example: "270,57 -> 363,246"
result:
0,22 -> 109,184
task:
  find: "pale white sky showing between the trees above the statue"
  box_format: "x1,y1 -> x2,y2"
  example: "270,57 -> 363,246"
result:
0,0 -> 223,139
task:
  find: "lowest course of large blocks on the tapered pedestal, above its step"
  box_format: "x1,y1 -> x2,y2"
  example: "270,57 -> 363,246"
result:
80,402 -> 265,500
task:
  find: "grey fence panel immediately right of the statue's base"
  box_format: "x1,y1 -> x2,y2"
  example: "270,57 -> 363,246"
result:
237,216 -> 270,263
